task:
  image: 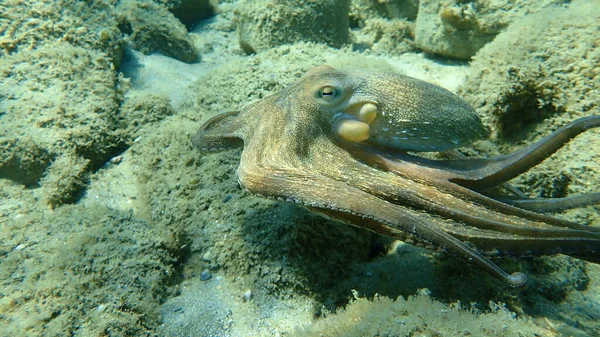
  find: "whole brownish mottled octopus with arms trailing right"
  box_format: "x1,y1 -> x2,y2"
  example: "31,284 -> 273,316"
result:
192,65 -> 600,287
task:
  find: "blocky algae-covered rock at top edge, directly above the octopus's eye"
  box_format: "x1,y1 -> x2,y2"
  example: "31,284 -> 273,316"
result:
236,0 -> 350,54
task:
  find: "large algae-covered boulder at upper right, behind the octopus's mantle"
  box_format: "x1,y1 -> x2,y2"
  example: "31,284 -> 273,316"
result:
461,1 -> 600,138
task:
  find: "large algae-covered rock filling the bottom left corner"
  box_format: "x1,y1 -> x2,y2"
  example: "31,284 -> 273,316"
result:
0,201 -> 179,337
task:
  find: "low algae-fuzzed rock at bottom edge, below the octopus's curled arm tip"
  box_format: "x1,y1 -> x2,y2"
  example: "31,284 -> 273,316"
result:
293,290 -> 553,337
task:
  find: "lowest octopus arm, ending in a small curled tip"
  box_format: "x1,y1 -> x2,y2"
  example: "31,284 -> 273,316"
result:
238,163 -> 527,287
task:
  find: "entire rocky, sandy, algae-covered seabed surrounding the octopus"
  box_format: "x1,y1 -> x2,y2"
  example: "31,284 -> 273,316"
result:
0,0 -> 600,337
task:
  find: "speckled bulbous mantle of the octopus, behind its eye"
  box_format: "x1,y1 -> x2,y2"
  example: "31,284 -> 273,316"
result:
322,67 -> 488,152
